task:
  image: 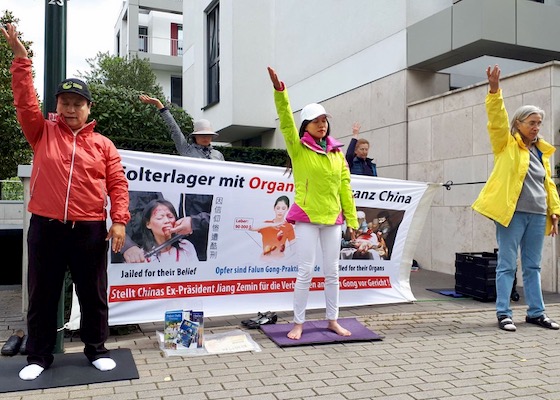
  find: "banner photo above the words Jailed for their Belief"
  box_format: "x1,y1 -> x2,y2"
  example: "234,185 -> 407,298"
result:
111,191 -> 214,264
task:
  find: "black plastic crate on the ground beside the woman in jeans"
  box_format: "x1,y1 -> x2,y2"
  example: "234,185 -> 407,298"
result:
455,252 -> 497,301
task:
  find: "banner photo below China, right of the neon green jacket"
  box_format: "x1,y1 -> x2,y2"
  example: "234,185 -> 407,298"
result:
340,207 -> 405,260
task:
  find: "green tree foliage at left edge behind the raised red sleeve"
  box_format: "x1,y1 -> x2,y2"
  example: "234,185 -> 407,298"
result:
0,10 -> 33,179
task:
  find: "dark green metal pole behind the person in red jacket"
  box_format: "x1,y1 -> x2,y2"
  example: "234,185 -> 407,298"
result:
43,0 -> 66,353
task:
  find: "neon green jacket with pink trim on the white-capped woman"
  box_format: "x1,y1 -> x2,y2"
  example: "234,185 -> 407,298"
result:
274,89 -> 358,229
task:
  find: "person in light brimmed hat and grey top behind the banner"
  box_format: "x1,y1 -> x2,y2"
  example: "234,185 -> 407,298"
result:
140,94 -> 224,161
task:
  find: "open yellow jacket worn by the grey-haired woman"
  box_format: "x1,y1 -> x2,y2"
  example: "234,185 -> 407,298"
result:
472,89 -> 560,234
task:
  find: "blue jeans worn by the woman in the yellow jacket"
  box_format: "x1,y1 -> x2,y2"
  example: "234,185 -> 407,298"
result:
496,212 -> 546,318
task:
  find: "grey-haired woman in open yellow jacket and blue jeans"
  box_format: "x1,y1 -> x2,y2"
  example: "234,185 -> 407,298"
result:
472,65 -> 560,332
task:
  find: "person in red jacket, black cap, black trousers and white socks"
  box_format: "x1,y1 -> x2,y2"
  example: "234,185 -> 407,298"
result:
0,24 -> 130,380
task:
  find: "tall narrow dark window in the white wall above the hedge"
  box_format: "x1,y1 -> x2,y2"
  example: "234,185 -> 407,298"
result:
206,3 -> 220,105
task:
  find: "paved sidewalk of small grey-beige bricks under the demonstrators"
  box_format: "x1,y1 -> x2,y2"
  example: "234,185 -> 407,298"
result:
0,270 -> 560,400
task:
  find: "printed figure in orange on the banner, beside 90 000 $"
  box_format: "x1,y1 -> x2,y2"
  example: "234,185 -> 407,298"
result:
250,196 -> 296,258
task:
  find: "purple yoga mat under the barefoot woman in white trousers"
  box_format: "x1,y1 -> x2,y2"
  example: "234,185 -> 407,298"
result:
260,318 -> 383,347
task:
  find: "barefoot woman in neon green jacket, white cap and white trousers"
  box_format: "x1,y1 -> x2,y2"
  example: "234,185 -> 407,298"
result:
268,67 -> 358,340
